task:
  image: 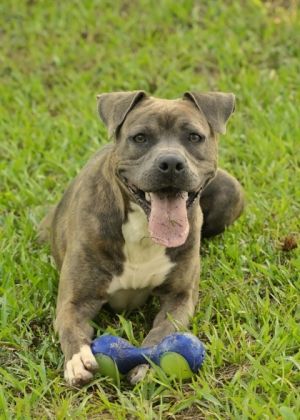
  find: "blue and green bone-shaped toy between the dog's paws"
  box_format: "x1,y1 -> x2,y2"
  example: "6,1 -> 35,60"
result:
91,333 -> 205,380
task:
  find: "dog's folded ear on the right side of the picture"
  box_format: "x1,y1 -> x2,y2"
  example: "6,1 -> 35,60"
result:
183,92 -> 235,134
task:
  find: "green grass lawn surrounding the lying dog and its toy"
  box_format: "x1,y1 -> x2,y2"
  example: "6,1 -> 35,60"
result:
0,0 -> 300,420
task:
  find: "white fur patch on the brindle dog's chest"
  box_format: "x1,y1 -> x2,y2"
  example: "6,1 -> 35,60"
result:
108,204 -> 175,297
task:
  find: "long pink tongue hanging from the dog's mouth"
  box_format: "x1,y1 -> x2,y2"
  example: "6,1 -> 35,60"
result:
148,192 -> 190,248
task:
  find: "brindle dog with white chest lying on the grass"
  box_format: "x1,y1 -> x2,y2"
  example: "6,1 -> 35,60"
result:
40,91 -> 244,385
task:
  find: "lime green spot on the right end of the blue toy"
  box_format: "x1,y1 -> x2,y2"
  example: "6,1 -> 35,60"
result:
160,352 -> 193,380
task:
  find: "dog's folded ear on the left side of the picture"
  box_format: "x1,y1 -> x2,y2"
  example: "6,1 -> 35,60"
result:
97,90 -> 147,136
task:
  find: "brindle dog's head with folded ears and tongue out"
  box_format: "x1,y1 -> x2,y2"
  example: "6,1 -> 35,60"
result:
98,91 -> 234,247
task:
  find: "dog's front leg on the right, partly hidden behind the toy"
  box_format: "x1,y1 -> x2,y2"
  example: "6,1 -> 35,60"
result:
128,269 -> 199,384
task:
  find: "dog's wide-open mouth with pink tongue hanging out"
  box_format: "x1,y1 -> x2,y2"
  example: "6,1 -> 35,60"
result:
123,179 -> 201,248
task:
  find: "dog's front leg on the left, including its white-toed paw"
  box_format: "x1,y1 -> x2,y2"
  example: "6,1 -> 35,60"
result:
55,251 -> 105,385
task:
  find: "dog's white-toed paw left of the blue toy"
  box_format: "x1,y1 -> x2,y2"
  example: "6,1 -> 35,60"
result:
64,344 -> 98,386
